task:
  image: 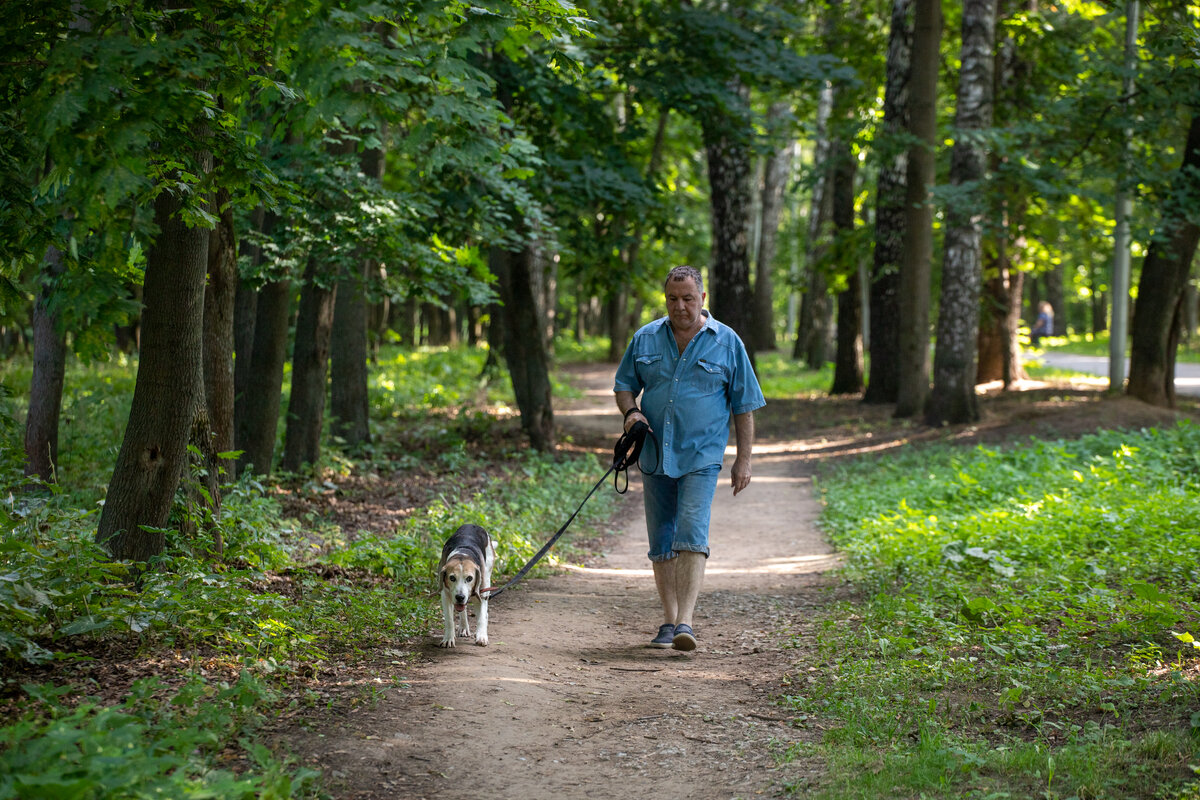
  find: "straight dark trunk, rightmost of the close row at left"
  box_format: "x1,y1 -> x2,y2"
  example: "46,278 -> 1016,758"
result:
329,260 -> 374,449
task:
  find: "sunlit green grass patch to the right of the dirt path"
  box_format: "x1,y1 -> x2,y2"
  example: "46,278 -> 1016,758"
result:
787,423 -> 1200,798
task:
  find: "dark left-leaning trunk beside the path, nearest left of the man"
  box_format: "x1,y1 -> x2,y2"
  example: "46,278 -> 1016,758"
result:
488,246 -> 554,452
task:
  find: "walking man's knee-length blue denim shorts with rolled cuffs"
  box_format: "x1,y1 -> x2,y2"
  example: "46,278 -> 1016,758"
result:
642,464 -> 721,561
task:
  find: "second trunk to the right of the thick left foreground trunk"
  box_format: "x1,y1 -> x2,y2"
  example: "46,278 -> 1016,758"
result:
235,279 -> 292,475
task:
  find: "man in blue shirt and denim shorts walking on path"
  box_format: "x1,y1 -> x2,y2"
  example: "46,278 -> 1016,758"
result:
613,266 -> 767,650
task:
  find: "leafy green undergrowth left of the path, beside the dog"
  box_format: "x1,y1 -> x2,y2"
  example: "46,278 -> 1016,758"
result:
0,340 -> 611,800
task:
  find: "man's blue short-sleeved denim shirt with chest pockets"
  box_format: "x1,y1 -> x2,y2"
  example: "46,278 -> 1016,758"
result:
613,311 -> 767,477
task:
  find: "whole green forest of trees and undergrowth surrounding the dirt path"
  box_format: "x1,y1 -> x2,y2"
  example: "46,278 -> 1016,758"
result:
0,0 -> 1200,800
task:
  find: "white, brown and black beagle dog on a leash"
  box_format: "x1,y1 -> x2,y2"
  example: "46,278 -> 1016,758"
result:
438,524 -> 496,648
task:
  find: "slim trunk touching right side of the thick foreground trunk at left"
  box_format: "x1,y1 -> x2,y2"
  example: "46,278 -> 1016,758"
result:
204,190 -> 238,471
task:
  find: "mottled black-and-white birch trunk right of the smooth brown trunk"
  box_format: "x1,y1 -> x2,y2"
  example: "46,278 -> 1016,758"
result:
925,0 -> 996,426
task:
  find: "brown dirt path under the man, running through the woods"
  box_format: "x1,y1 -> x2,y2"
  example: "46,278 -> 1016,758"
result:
298,367 -> 835,800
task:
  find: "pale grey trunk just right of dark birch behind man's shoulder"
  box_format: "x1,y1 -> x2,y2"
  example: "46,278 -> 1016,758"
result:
748,102 -> 796,350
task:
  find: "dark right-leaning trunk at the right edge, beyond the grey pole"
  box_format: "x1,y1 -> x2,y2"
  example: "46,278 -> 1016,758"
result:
1126,115 -> 1200,408
